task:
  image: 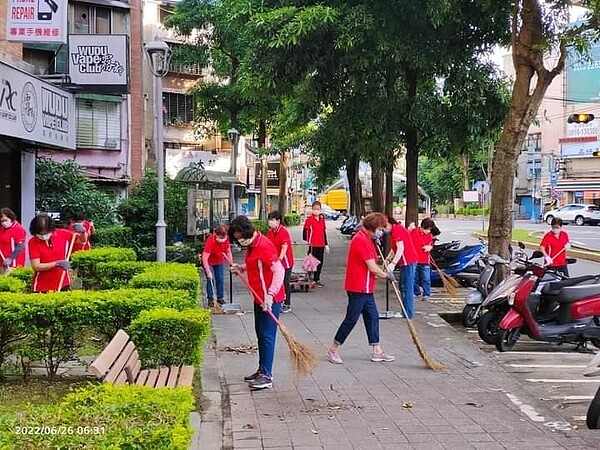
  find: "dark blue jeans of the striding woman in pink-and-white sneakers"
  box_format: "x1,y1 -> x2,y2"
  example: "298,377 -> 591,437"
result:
334,292 -> 379,345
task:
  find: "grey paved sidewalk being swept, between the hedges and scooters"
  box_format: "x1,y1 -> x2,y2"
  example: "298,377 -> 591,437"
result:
192,229 -> 598,450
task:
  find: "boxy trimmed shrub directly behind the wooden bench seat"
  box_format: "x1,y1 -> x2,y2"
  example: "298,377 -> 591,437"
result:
128,308 -> 211,368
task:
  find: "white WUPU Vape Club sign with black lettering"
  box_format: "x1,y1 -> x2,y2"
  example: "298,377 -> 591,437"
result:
69,34 -> 129,93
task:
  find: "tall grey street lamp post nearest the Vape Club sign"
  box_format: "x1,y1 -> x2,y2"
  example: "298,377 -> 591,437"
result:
144,38 -> 173,262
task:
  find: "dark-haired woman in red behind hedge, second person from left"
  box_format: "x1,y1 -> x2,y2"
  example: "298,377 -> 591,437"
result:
28,213 -> 85,292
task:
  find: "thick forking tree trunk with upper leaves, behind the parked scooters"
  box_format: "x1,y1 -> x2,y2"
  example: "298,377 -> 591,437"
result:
488,0 -> 600,257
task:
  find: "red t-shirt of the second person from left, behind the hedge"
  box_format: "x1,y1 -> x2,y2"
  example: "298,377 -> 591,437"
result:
28,229 -> 73,292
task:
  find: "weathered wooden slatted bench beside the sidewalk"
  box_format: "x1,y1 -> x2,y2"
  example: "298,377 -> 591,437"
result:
89,330 -> 194,388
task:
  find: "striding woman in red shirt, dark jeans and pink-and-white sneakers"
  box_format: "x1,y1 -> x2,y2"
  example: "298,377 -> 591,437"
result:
327,213 -> 395,364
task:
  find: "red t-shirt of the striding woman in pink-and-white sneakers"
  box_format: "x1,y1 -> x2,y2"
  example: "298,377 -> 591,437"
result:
344,228 -> 377,294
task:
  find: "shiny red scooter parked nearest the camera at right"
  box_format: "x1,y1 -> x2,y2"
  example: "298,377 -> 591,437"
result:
496,264 -> 600,352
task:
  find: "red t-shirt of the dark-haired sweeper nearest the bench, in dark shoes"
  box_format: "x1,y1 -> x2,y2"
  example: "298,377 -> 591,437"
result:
244,233 -> 285,305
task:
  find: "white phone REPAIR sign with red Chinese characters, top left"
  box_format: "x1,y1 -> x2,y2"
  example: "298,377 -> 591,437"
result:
6,0 -> 68,44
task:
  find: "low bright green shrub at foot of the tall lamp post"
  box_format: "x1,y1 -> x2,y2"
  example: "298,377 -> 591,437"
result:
129,263 -> 200,306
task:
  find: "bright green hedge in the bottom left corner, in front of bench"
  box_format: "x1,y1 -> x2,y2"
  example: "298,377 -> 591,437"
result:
0,384 -> 194,450
